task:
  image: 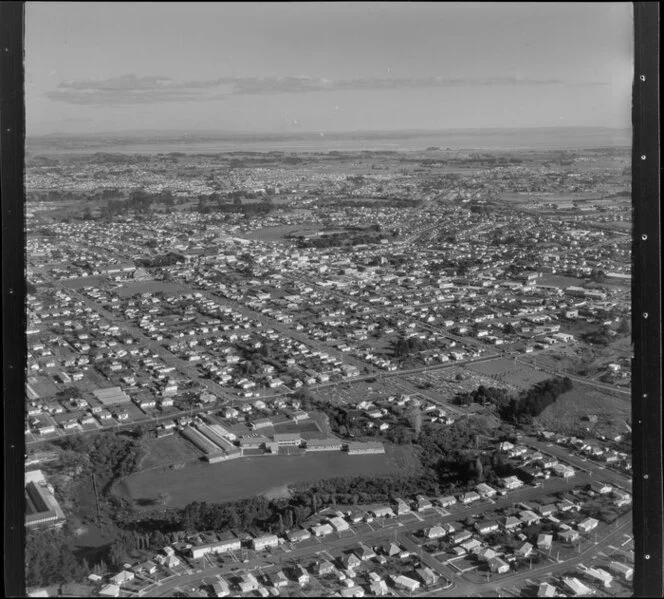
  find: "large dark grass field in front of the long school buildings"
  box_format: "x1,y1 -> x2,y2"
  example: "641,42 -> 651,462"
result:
114,447 -> 419,507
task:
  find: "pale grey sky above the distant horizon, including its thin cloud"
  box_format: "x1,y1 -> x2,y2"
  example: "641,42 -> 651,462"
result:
25,1 -> 633,135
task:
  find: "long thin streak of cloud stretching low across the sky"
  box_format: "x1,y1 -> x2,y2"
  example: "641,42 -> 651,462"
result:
46,74 -> 604,105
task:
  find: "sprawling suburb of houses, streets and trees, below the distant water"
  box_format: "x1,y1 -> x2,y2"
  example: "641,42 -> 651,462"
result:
25,144 -> 634,597
